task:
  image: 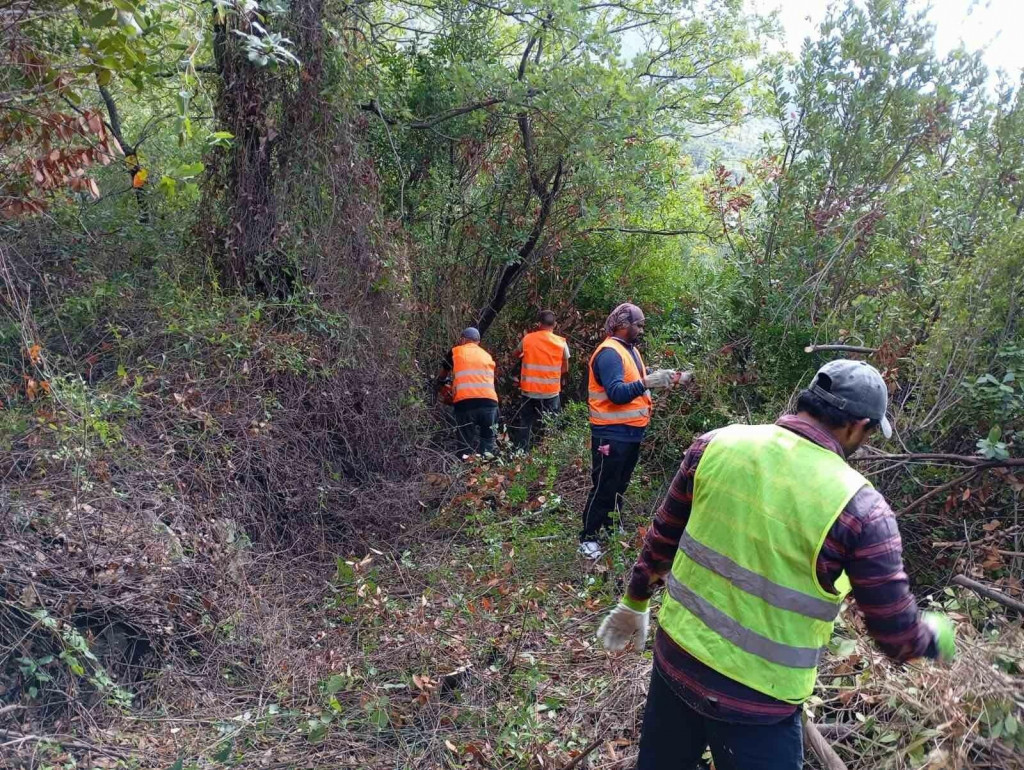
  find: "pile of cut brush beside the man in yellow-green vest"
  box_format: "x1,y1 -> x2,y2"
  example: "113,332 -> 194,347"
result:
808,589 -> 1024,770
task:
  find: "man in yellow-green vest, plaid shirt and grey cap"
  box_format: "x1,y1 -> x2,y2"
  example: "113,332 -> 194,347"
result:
597,359 -> 955,770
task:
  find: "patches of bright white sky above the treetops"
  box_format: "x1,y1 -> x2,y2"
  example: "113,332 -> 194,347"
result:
751,0 -> 1024,75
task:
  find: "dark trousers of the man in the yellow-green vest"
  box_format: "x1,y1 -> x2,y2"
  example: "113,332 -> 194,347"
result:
637,668 -> 804,770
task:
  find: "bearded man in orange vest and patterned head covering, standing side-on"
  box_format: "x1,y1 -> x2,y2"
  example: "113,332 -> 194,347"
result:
580,302 -> 691,559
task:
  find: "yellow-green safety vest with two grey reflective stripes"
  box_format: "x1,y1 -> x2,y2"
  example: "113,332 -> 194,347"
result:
658,425 -> 867,703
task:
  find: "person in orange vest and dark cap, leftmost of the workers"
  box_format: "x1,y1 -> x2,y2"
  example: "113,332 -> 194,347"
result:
437,327 -> 498,456
